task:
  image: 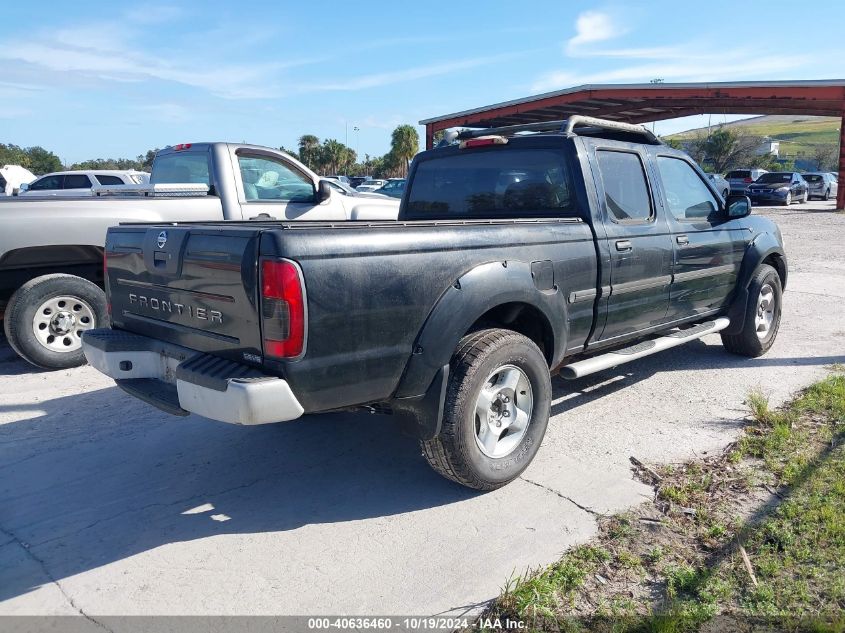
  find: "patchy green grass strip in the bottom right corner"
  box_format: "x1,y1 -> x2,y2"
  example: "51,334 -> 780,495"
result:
482,367 -> 845,631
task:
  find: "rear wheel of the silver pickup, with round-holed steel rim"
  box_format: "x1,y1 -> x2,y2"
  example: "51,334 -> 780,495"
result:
3,274 -> 108,369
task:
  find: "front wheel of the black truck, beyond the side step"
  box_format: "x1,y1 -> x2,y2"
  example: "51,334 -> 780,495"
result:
722,264 -> 783,358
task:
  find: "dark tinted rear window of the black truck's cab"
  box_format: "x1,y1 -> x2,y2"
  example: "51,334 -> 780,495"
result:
408,149 -> 577,219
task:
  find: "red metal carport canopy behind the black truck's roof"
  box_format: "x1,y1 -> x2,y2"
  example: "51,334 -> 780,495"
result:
420,79 -> 845,209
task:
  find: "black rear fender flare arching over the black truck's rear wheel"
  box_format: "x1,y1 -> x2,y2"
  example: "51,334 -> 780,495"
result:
395,261 -> 568,398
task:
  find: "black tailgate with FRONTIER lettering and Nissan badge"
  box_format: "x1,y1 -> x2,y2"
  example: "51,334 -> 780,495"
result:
106,226 -> 261,363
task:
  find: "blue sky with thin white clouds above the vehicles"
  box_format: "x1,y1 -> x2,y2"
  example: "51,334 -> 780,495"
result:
0,0 -> 845,164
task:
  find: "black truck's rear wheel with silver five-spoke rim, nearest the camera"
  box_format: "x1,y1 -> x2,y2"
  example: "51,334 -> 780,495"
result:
420,329 -> 552,490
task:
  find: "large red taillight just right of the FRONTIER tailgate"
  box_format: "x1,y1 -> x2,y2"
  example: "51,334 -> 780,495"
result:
261,259 -> 305,358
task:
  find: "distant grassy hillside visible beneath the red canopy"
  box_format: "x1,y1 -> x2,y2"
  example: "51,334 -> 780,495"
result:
668,114 -> 839,156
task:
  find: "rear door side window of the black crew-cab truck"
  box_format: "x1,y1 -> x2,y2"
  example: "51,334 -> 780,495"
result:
596,150 -> 652,222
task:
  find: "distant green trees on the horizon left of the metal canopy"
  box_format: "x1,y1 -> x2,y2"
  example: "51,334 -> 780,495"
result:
0,125 -> 420,178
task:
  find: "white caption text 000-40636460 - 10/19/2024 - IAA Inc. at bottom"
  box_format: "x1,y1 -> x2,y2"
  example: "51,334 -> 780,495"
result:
308,617 -> 525,631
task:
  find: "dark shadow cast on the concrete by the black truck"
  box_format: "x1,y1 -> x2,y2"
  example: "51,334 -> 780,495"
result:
0,330 -> 845,600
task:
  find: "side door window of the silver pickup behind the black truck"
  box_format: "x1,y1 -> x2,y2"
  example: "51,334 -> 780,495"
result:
238,156 -> 315,202
